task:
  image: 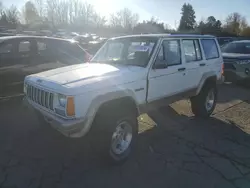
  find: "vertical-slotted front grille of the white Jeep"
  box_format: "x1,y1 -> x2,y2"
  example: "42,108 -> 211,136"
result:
27,85 -> 54,110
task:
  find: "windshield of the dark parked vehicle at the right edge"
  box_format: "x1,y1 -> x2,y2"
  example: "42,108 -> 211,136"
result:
221,42 -> 250,54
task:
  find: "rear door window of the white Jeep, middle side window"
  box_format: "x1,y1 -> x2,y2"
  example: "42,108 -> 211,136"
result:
182,40 -> 202,63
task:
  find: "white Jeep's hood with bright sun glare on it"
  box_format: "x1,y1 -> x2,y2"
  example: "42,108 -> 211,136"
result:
27,63 -> 146,93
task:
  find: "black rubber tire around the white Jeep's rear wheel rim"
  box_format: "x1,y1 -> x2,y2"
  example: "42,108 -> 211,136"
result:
190,83 -> 217,118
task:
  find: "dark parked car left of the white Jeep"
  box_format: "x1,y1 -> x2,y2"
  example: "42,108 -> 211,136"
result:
0,36 -> 91,98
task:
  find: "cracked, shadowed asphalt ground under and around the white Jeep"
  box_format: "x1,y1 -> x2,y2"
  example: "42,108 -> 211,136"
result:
0,85 -> 250,188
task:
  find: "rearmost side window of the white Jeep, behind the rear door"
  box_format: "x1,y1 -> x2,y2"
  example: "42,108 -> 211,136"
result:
201,39 -> 220,59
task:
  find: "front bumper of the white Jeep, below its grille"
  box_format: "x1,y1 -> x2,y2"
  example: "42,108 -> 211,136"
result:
23,97 -> 90,138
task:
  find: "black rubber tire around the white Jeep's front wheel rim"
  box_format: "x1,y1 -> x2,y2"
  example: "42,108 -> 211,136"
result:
88,109 -> 138,164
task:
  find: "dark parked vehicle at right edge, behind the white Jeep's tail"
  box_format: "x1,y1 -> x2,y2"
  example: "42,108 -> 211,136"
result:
221,40 -> 250,82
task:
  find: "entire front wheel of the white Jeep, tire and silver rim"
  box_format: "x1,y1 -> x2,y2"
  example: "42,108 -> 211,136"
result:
90,111 -> 138,164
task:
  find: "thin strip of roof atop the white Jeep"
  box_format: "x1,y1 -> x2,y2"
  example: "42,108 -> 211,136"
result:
112,34 -> 215,39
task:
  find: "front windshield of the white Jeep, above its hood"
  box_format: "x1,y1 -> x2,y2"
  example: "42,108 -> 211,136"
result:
91,37 -> 158,67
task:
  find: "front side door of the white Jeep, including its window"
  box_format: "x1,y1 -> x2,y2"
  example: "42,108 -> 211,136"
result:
147,39 -> 186,102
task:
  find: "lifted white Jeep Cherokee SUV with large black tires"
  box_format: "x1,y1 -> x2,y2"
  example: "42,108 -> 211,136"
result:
24,34 -> 223,162
